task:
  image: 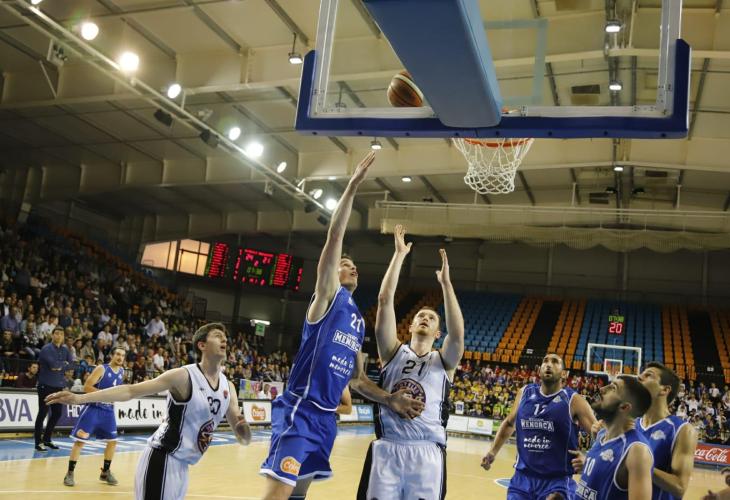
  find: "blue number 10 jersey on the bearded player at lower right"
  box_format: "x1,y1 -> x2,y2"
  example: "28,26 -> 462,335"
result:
575,429 -> 653,500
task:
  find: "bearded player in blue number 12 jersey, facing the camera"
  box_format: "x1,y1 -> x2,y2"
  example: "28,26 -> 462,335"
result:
482,354 -> 596,500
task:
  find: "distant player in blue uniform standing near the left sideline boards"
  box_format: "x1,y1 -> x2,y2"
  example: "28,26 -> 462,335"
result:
63,347 -> 127,486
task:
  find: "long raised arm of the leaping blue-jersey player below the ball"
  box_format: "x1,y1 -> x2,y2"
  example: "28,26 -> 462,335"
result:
307,152 -> 375,323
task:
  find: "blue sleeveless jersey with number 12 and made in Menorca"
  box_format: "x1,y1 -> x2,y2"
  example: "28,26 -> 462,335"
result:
515,384 -> 578,478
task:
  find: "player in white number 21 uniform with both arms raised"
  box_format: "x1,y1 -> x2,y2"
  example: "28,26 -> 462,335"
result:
357,225 -> 464,500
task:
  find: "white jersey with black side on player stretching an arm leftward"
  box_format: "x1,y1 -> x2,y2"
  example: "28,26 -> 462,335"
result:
147,364 -> 231,465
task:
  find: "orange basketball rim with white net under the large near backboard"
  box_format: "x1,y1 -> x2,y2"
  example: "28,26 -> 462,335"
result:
454,138 -> 535,194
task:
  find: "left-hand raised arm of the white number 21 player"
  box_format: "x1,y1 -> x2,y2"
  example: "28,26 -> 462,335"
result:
375,224 -> 411,364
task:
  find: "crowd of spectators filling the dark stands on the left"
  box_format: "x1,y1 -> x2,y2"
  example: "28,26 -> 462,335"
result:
0,225 -> 290,398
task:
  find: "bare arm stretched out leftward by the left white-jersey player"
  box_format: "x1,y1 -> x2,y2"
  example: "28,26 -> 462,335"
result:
46,368 -> 191,405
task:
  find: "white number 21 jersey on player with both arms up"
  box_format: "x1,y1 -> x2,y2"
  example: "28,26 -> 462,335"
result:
375,344 -> 451,445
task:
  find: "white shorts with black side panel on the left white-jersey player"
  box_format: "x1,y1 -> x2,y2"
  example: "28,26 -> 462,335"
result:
134,446 -> 188,500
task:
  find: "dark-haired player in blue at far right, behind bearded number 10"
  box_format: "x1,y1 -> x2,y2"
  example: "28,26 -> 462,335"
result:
636,362 -> 697,500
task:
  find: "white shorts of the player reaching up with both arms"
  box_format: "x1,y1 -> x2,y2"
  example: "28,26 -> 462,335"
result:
357,439 -> 446,500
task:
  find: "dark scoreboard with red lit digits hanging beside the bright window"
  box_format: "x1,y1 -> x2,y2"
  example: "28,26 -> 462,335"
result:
205,242 -> 304,290
